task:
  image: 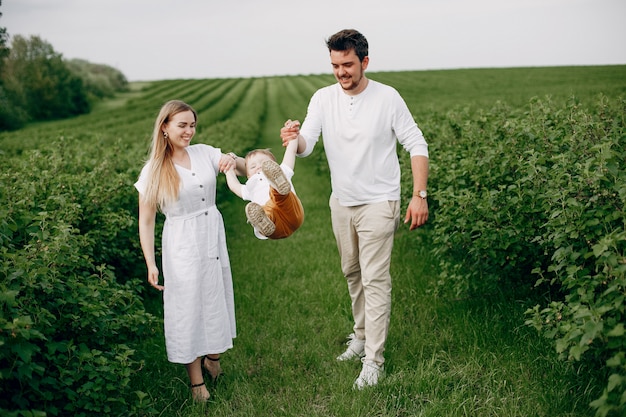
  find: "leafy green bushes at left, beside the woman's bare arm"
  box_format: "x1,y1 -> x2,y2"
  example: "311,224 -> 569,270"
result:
0,138 -> 155,416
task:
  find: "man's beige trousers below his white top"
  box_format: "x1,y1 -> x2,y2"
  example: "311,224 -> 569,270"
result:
330,197 -> 400,365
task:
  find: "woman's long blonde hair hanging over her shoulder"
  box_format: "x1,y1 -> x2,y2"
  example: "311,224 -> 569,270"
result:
142,100 -> 198,209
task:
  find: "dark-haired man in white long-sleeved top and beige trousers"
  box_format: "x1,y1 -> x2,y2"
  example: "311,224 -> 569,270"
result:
281,29 -> 428,389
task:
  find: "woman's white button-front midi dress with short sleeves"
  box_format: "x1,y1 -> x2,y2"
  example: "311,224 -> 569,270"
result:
135,144 -> 236,364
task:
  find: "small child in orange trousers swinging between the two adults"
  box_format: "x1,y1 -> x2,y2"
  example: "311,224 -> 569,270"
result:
226,140 -> 304,239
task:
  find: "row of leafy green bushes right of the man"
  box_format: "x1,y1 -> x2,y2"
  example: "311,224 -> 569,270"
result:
404,96 -> 626,416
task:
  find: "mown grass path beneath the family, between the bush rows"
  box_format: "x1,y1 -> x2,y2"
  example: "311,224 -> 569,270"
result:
138,160 -> 597,417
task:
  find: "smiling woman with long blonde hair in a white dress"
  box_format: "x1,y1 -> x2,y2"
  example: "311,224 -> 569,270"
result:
135,100 -> 236,402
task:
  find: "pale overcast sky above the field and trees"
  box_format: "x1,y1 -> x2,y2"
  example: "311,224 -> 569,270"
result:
0,0 -> 626,81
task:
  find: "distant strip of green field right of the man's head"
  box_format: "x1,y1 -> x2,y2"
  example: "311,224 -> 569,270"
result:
371,65 -> 626,112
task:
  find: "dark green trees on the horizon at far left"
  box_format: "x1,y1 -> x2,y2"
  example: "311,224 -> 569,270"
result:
0,0 -> 128,131
